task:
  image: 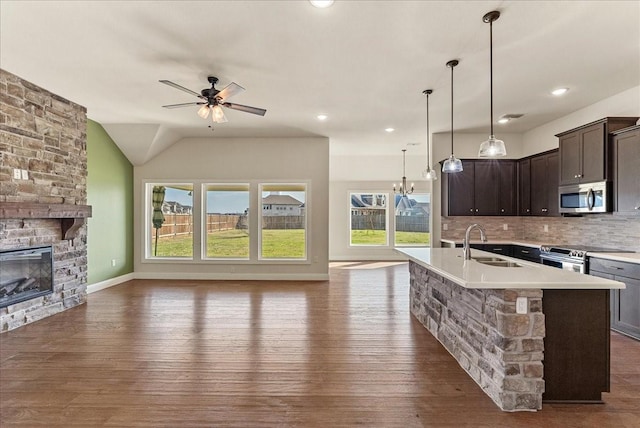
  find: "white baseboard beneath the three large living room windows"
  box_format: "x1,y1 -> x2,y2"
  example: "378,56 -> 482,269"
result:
135,272 -> 329,281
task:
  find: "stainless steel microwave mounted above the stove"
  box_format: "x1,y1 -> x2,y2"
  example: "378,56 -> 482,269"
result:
558,181 -> 611,214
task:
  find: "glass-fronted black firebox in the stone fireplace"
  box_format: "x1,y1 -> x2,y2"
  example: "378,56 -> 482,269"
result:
0,246 -> 53,308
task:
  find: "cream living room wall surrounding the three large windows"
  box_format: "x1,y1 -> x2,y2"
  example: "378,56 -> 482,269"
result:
134,138 -> 329,280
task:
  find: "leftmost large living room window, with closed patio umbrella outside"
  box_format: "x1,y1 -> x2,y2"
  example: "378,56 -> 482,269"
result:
147,183 -> 193,258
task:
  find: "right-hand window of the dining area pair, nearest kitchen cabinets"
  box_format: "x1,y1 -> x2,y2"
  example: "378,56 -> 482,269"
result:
395,194 -> 431,245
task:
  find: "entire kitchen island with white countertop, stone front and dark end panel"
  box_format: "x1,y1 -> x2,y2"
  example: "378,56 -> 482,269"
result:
398,248 -> 624,411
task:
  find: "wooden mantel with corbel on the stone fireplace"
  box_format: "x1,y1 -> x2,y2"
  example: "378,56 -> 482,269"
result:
0,202 -> 91,240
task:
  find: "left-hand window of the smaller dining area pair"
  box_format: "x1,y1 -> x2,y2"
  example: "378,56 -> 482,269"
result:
350,193 -> 387,245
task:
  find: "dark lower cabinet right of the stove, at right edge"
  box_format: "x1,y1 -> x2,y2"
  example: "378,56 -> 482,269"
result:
589,257 -> 640,339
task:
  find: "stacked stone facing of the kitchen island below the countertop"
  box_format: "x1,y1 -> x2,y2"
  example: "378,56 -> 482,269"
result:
409,262 -> 545,411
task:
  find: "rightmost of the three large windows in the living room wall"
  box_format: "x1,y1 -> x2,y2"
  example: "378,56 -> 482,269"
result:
259,183 -> 307,259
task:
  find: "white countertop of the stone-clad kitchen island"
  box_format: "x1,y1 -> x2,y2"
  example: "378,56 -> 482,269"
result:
396,247 -> 625,290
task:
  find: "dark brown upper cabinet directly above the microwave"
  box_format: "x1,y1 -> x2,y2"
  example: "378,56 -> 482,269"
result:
556,117 -> 638,185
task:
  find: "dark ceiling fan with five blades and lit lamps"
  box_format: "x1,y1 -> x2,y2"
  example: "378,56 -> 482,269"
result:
159,76 -> 267,123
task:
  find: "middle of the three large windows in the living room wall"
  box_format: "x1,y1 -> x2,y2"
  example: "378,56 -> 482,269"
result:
202,184 -> 249,259
